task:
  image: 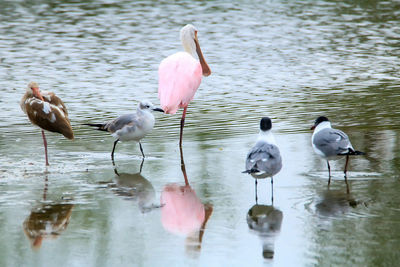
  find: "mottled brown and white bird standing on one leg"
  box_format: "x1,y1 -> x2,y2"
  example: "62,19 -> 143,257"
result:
21,82 -> 74,166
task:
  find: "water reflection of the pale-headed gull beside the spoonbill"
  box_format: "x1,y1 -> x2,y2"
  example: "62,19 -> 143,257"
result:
109,158 -> 160,213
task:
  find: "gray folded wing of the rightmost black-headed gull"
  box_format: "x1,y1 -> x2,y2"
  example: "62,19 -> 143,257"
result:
313,128 -> 353,157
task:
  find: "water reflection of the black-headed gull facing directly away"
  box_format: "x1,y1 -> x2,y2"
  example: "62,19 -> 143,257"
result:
246,192 -> 283,259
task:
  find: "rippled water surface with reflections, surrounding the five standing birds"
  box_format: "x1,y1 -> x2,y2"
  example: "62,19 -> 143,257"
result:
0,0 -> 400,266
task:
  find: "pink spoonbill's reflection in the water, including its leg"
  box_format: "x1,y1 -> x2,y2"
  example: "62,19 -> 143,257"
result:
160,148 -> 213,255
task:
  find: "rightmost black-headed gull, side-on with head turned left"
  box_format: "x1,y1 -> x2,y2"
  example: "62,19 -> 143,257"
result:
311,116 -> 365,185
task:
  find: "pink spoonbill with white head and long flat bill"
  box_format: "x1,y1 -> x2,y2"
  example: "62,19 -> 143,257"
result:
158,24 -> 211,146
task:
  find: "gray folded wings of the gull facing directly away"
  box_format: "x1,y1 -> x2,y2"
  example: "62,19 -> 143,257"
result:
246,142 -> 282,176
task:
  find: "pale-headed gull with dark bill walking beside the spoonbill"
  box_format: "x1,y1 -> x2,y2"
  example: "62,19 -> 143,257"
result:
84,101 -> 164,162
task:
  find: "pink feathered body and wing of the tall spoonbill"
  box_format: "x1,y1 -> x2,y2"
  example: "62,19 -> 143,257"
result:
158,52 -> 202,114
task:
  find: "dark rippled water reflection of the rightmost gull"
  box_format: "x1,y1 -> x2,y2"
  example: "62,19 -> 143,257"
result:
315,183 -> 359,216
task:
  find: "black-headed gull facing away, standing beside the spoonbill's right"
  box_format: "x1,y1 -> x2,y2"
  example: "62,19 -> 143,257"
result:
243,117 -> 282,201
